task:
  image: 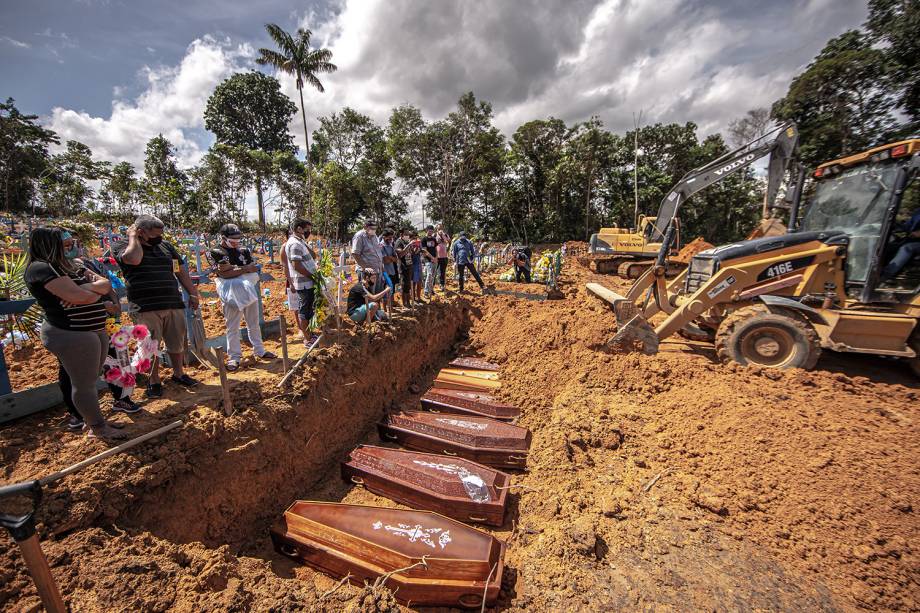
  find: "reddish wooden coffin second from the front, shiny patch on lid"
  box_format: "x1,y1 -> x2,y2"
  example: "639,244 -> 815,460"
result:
342,445 -> 511,526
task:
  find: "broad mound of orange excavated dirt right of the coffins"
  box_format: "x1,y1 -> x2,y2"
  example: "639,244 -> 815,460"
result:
460,260 -> 920,610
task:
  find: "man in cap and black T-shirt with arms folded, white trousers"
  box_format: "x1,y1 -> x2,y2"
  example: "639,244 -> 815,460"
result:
208,223 -> 277,372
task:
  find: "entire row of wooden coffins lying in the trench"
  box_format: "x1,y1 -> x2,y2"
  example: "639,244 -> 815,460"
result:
271,358 -> 531,608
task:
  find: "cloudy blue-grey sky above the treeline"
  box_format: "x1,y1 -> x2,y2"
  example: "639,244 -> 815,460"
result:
0,0 -> 866,220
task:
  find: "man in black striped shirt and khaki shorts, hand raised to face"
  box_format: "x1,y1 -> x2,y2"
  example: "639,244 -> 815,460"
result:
112,215 -> 199,398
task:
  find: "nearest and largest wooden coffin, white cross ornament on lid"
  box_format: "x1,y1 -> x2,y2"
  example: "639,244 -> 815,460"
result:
271,500 -> 505,609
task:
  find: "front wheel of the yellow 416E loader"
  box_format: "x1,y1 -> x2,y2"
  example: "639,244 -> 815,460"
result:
716,305 -> 821,370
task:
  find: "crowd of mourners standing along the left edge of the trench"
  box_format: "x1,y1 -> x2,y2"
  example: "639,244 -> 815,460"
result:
18,215 -> 500,439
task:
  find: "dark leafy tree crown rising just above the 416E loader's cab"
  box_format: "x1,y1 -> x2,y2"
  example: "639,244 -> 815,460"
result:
772,30 -> 896,166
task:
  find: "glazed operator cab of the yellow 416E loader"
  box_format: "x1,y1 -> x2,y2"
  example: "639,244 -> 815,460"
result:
796,139 -> 920,303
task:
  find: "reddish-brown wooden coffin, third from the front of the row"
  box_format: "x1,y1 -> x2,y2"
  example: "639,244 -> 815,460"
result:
378,411 -> 530,468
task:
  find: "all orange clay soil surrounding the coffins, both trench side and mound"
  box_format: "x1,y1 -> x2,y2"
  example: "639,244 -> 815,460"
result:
0,258 -> 920,612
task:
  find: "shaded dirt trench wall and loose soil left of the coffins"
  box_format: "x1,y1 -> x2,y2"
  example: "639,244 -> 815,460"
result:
0,303 -> 469,611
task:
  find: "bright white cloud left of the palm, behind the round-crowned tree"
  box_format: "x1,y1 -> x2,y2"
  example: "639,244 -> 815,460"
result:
47,36 -> 253,169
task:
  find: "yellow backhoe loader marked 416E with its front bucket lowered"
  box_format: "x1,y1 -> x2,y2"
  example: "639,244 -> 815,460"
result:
588,139 -> 920,375
